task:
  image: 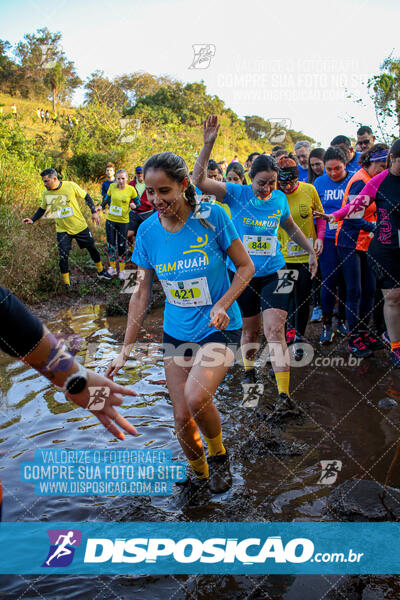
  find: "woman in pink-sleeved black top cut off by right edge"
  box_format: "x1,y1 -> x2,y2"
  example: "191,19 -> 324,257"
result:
320,139 -> 400,367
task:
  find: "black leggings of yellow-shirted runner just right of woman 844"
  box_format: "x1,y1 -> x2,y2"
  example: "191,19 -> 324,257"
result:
286,262 -> 312,335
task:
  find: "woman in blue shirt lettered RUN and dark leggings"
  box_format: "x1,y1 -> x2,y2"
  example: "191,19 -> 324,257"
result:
314,148 -> 351,344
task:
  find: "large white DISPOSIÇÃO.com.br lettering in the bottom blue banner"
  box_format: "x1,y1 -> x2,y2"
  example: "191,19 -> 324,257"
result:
84,536 -> 363,565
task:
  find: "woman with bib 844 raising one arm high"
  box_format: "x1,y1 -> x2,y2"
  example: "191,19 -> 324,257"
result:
193,116 -> 317,410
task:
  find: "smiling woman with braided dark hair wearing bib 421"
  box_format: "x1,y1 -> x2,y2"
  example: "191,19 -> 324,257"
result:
107,152 -> 254,496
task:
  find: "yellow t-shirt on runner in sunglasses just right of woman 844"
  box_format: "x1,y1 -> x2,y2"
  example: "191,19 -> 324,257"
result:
278,181 -> 324,263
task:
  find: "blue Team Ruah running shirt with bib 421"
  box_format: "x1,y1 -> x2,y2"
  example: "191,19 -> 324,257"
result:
132,203 -> 242,342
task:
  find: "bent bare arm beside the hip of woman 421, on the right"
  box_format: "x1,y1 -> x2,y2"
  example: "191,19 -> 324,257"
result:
209,238 -> 254,329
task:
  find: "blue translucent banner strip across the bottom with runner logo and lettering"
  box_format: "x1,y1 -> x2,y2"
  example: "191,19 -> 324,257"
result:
0,522 -> 400,575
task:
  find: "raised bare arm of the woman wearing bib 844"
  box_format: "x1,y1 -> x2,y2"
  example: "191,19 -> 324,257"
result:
192,115 -> 226,202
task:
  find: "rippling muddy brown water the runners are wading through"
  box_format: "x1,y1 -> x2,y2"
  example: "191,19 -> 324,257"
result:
0,306 -> 400,600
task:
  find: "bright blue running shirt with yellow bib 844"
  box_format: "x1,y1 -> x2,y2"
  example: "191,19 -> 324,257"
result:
224,183 -> 290,277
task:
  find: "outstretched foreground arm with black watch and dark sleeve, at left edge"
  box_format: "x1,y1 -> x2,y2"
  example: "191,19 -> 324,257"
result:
0,286 -> 137,440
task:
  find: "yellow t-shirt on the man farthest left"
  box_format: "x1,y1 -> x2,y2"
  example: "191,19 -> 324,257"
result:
40,181 -> 88,235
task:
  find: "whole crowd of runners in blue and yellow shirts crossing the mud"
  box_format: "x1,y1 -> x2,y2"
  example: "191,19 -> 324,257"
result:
0,116 -> 400,502
